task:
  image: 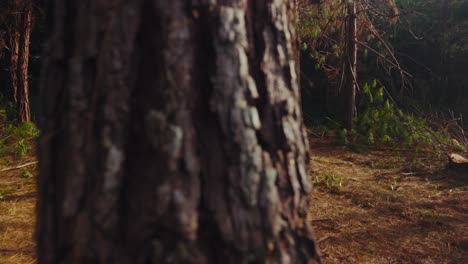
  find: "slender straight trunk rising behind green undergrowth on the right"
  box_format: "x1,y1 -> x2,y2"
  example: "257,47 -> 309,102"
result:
343,0 -> 357,130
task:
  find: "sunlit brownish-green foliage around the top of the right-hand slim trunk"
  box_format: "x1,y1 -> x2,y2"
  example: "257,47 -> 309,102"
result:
296,0 -> 398,80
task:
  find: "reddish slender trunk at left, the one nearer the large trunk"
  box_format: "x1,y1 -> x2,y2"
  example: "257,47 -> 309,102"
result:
15,0 -> 32,122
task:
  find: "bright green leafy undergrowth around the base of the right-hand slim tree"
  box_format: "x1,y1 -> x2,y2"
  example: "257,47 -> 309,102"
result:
321,80 -> 467,151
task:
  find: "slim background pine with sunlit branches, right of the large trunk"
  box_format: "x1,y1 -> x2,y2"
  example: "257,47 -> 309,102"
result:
299,0 -> 407,126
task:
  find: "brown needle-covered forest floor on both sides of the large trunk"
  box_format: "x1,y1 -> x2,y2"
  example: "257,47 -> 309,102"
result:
0,127 -> 468,264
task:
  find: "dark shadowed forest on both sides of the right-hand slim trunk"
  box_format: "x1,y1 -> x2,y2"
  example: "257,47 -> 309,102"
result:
299,0 -> 468,125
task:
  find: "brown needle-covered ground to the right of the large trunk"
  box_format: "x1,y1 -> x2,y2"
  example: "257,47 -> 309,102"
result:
310,141 -> 468,264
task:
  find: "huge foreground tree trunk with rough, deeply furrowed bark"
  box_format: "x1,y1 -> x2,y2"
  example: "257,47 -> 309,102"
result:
36,0 -> 318,263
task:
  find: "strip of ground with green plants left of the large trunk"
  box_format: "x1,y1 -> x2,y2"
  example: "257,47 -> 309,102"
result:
0,118 -> 38,264
